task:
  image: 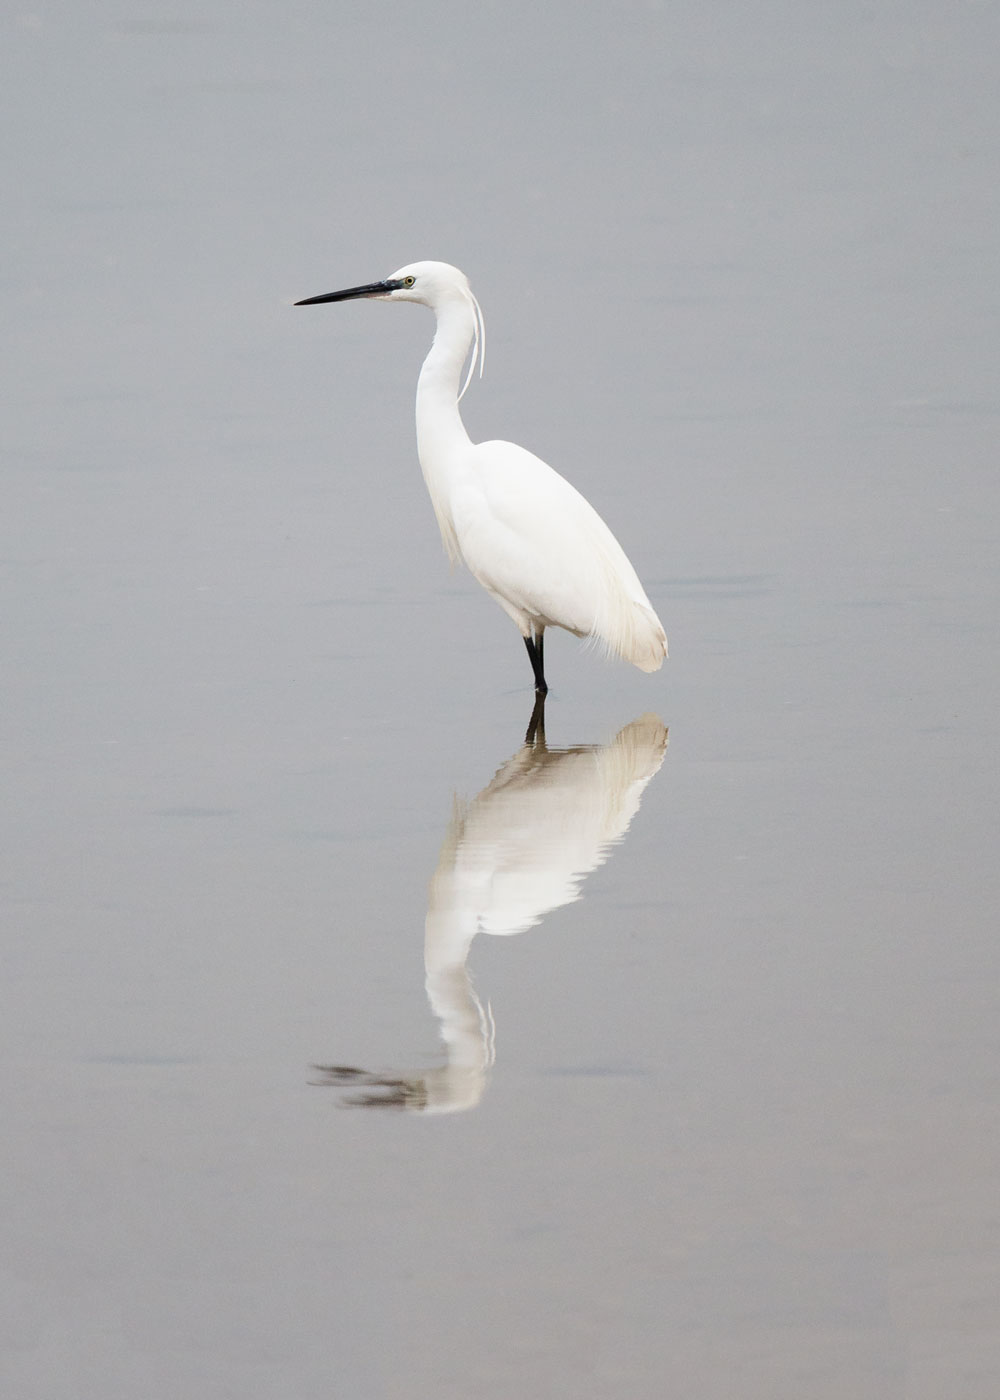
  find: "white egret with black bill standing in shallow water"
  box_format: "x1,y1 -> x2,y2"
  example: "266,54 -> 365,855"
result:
296,262 -> 667,696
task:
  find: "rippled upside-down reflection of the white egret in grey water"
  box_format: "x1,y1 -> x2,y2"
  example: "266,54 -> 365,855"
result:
317,696 -> 667,1113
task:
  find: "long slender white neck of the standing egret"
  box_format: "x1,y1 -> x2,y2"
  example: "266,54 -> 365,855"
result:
416,297 -> 476,559
